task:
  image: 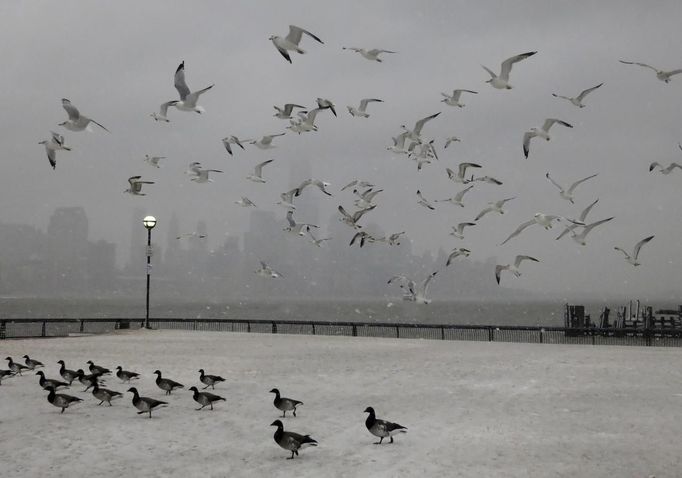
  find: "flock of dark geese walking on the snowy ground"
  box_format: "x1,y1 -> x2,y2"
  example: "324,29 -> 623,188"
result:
0,355 -> 407,459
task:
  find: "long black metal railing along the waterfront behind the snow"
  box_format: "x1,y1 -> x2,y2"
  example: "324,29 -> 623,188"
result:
0,318 -> 682,347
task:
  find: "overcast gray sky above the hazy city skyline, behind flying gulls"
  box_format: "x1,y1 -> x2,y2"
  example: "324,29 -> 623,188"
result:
0,0 -> 682,300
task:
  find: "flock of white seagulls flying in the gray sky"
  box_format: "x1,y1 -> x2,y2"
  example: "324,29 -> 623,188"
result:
33,21 -> 682,304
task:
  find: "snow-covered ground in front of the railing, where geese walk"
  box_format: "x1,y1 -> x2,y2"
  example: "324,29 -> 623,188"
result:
0,330 -> 682,478
